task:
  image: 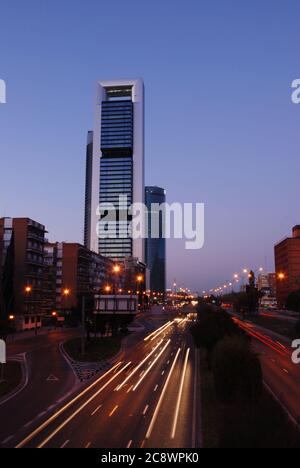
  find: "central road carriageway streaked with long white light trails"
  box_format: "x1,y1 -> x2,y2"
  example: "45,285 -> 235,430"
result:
8,318 -> 201,448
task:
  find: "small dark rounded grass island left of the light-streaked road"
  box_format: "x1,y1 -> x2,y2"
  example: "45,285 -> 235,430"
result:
64,336 -> 122,362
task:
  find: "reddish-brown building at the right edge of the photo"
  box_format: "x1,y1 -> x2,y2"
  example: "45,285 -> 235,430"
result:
275,225 -> 300,307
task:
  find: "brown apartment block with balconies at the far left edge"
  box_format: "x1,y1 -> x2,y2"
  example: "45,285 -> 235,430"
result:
0,218 -> 46,330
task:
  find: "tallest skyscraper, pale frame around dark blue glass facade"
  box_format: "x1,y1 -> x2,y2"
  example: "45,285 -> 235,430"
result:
84,79 -> 145,262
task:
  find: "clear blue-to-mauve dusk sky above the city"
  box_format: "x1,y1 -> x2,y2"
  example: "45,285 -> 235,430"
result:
0,0 -> 300,291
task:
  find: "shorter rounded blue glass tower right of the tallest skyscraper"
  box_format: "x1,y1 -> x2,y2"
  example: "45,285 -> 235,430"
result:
145,187 -> 166,293
